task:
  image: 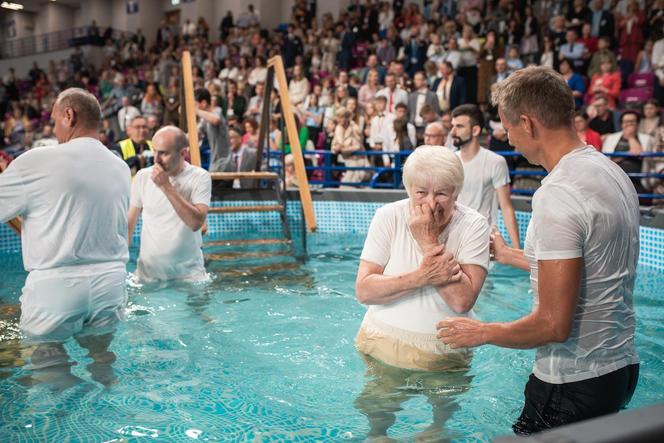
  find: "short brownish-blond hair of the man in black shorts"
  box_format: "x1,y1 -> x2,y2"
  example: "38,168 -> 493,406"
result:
491,66 -> 574,129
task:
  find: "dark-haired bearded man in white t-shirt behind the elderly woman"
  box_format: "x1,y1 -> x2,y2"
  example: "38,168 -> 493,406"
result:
451,104 -> 520,248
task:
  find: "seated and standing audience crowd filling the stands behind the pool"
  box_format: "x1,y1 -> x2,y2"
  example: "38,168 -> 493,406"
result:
0,0 -> 664,199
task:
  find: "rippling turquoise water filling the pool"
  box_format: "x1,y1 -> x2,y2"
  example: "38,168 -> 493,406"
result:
0,234 -> 664,442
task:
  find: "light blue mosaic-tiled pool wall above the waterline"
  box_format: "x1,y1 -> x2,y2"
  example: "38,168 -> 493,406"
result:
0,200 -> 664,270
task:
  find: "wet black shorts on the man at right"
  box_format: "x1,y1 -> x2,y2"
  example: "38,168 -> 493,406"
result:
512,364 -> 639,435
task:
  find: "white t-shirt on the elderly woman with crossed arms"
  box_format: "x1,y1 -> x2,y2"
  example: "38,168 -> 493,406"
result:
361,199 -> 489,334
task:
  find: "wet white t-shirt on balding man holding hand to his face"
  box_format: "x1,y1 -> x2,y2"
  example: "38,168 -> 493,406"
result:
130,163 -> 212,281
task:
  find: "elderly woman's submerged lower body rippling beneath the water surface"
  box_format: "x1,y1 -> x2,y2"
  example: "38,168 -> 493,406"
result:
354,355 -> 473,442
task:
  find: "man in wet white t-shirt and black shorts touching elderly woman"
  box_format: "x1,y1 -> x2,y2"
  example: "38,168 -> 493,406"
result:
438,67 -> 640,434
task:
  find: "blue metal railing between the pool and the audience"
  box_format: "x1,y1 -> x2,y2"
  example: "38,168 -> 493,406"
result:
268,150 -> 664,199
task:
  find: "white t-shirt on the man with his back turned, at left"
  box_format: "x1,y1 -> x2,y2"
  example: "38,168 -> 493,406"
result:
0,137 -> 131,271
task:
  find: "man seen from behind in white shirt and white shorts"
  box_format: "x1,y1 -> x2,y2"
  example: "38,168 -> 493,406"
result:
0,88 -> 131,389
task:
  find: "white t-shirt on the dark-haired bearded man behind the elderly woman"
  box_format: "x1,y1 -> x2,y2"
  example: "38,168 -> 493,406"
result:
456,148 -> 510,225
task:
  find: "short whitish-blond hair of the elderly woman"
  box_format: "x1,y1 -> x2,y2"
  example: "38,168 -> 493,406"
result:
403,145 -> 464,197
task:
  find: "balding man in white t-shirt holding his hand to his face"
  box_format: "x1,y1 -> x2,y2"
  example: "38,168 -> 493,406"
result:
129,126 -> 212,281
